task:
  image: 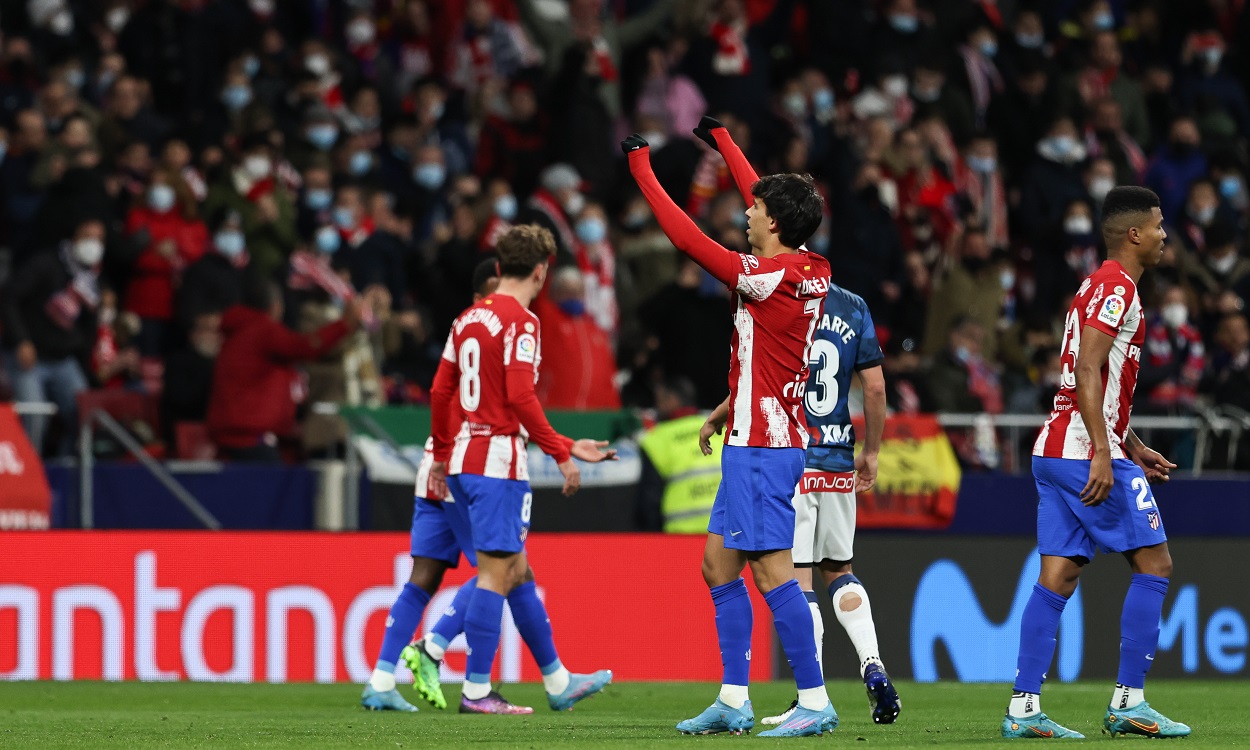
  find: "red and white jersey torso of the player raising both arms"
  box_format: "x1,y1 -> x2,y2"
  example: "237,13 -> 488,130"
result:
725,250 -> 829,449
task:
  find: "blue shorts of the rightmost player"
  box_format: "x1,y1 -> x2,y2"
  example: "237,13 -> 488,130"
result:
1033,456 -> 1168,560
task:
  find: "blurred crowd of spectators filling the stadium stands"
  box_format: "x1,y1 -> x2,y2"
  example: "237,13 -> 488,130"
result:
0,0 -> 1250,454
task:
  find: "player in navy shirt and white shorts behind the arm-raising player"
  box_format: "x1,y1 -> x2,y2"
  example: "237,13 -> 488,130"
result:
699,284 -> 901,725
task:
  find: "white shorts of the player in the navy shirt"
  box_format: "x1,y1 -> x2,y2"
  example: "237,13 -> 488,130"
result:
794,469 -> 855,565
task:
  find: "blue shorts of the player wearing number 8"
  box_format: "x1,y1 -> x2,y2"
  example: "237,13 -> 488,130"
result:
448,474 -> 534,553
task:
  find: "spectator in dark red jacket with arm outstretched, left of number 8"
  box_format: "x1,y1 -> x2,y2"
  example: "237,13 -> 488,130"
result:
208,281 -> 359,463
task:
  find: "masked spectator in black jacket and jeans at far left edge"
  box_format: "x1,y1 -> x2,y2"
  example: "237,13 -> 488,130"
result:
0,219 -> 105,455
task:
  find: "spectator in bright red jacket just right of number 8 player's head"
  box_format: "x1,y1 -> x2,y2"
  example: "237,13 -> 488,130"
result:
534,268 -> 621,410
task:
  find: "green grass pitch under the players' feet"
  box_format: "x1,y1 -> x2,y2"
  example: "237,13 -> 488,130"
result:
0,680 -> 1250,750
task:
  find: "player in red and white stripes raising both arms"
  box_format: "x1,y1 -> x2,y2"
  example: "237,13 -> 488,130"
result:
621,118 -> 838,736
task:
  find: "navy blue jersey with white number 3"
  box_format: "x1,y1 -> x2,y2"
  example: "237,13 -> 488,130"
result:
803,284 -> 885,471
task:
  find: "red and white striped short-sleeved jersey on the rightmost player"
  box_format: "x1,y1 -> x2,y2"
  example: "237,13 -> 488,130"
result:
1033,260 -> 1146,460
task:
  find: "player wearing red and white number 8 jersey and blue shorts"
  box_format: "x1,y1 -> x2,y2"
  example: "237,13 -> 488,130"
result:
429,225 -> 616,714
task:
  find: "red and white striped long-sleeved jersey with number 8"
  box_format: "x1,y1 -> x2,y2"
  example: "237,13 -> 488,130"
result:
431,294 -> 573,480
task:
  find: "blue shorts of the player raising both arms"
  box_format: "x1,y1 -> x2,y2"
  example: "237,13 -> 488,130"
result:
708,445 -> 806,553
